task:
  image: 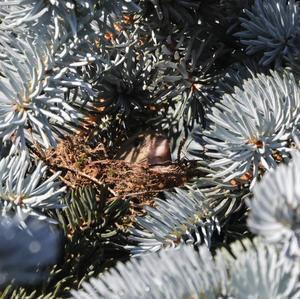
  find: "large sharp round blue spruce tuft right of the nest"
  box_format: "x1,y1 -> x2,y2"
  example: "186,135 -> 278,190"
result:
203,69 -> 300,186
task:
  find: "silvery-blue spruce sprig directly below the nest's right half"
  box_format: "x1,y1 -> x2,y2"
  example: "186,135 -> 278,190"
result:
130,189 -> 220,254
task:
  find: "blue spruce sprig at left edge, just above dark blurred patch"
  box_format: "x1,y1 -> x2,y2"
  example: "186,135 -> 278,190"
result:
0,152 -> 66,214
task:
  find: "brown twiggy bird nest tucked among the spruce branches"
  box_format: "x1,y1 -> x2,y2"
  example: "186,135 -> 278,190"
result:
32,135 -> 192,229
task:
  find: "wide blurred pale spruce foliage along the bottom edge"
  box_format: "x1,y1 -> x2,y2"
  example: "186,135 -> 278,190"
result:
73,240 -> 300,299
